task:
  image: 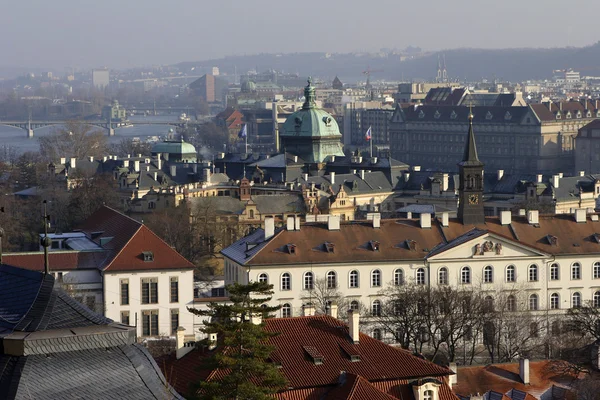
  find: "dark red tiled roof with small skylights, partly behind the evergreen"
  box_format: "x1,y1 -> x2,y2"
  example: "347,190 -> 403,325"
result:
161,315 -> 456,400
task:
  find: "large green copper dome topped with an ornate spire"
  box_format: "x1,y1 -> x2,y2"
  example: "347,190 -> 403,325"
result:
280,78 -> 344,163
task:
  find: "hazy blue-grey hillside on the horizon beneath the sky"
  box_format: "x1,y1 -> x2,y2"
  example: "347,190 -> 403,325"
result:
177,42 -> 600,82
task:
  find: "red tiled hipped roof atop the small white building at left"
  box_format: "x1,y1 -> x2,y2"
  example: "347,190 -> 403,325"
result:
75,206 -> 194,271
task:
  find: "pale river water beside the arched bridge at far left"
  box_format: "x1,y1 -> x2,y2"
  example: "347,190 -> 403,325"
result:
0,115 -> 186,153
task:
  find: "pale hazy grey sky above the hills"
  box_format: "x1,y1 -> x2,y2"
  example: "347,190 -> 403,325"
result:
0,0 -> 600,70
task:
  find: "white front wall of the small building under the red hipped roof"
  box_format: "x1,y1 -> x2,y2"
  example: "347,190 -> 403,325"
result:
104,269 -> 194,337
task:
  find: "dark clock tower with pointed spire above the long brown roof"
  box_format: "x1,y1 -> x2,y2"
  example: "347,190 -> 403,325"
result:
458,111 -> 485,225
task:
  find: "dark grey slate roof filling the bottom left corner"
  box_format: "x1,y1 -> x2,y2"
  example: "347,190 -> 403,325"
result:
0,264 -> 182,400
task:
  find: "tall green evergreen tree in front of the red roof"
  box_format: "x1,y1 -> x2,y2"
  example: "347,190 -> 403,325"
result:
190,282 -> 286,400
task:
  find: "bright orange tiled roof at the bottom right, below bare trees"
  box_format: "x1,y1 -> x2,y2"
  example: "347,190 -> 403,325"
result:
452,360 -> 574,398
